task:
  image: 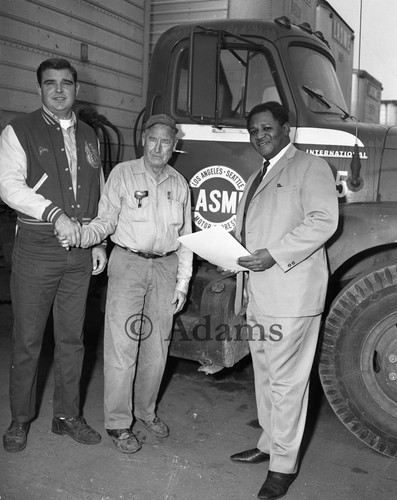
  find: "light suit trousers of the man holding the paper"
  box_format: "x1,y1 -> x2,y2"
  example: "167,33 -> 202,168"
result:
247,294 -> 321,474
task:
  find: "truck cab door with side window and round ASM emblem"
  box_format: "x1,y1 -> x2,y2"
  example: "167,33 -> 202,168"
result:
167,29 -> 284,231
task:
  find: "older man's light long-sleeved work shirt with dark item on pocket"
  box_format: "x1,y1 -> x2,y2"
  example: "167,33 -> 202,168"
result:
82,158 -> 193,294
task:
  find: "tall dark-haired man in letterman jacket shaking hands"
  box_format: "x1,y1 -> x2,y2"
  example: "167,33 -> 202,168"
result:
0,59 -> 106,452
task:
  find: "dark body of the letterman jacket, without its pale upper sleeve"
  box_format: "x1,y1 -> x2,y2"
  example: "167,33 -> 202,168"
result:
2,109 -> 101,232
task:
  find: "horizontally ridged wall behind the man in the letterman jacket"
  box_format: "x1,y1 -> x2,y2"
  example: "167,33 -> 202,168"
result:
0,0 -> 150,159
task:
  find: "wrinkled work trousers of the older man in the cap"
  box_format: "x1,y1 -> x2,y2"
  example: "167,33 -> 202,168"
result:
104,246 -> 178,429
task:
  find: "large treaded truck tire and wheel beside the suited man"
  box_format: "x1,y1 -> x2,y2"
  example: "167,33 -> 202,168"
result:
319,264 -> 397,457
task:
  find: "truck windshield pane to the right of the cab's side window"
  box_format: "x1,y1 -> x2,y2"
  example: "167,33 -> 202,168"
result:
289,45 -> 347,114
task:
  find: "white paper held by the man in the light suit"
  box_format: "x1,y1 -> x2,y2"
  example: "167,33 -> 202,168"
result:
178,226 -> 251,271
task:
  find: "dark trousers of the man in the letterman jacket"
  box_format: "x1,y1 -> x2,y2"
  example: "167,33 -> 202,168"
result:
10,229 -> 92,422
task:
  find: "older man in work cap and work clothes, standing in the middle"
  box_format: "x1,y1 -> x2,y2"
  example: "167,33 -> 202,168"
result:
59,114 -> 192,453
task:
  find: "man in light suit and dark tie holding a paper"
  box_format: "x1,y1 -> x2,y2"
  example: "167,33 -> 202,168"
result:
230,102 -> 338,499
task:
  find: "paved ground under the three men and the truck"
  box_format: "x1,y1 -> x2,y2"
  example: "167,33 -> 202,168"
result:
0,280 -> 397,500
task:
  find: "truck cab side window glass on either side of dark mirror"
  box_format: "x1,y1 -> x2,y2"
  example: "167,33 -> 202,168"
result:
174,47 -> 281,123
